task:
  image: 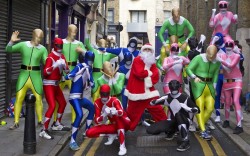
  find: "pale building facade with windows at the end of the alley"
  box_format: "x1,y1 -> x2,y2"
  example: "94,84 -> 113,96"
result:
108,0 -> 179,54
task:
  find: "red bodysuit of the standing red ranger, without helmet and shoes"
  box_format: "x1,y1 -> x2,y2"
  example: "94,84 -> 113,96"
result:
43,51 -> 69,130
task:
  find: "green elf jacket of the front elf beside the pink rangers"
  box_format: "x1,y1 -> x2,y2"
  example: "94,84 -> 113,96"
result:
186,54 -> 221,99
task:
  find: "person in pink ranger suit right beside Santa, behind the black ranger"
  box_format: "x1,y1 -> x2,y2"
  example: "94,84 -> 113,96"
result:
163,43 -> 190,94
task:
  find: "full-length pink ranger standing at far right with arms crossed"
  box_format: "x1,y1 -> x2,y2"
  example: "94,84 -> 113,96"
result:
216,40 -> 243,134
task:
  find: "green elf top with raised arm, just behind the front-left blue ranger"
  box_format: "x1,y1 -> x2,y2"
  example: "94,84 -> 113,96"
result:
85,38 -> 116,93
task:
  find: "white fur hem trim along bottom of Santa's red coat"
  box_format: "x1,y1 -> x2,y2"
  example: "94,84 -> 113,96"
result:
124,89 -> 160,101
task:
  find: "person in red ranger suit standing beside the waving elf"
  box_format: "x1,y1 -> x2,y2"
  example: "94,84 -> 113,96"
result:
39,38 -> 69,139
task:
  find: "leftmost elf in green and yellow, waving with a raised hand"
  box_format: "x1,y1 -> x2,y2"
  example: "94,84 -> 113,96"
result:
6,29 -> 48,130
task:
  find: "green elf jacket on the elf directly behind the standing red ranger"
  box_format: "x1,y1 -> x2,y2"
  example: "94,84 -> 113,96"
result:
62,39 -> 86,71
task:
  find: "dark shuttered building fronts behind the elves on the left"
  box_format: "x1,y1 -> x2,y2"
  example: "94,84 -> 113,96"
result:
0,0 -> 106,118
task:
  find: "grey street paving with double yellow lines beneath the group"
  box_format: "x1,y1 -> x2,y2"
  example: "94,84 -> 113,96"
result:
0,80 -> 250,156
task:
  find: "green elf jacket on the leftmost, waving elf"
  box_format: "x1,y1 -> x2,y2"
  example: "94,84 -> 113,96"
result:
6,41 -> 48,95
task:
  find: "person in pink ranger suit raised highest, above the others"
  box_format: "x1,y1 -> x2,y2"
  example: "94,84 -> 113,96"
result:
209,1 -> 238,41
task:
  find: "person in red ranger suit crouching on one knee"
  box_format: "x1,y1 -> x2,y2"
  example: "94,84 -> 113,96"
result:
86,84 -> 130,155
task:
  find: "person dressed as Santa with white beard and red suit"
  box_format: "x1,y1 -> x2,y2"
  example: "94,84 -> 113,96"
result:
124,43 -> 167,131
